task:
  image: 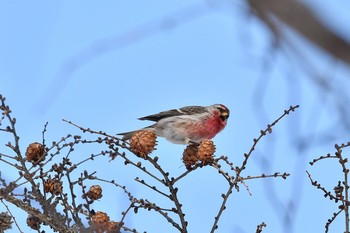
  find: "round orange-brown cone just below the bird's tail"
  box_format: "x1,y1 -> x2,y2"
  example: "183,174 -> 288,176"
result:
130,130 -> 157,158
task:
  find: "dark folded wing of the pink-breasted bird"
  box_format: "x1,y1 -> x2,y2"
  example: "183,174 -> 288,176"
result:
139,106 -> 206,121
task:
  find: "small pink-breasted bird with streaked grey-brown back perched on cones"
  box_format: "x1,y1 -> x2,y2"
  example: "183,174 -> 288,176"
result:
118,104 -> 230,144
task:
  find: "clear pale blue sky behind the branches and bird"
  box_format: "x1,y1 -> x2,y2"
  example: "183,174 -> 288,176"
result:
0,1 -> 349,233
